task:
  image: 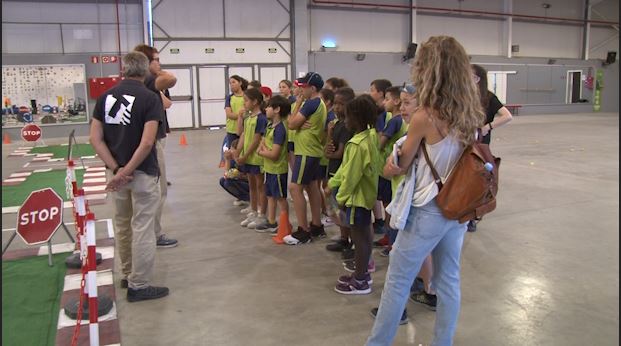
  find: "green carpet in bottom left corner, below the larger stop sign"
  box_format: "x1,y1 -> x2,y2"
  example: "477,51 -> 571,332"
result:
2,253 -> 69,346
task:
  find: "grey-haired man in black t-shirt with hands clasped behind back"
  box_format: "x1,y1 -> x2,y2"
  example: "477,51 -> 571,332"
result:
90,52 -> 168,302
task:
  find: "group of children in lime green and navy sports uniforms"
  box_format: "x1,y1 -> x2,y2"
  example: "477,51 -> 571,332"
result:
223,72 -> 427,294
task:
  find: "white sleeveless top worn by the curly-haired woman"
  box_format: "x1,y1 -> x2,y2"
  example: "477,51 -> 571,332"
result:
412,135 -> 464,207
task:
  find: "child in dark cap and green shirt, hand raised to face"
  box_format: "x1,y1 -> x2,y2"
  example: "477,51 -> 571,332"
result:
284,72 -> 327,245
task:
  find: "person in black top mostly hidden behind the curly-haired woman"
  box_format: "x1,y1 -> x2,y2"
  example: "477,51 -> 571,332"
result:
468,64 -> 513,232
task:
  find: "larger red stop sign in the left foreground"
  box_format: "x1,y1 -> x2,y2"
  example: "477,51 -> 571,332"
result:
17,187 -> 63,245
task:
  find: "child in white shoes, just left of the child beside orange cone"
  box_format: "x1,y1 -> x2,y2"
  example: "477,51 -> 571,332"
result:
235,88 -> 267,228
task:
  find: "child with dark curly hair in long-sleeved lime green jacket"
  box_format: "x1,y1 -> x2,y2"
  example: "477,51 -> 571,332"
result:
325,95 -> 380,294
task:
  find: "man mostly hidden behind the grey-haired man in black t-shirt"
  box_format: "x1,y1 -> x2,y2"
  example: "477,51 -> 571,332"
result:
134,44 -> 177,248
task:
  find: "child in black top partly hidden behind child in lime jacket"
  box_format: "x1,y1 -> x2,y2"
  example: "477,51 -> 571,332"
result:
324,87 -> 356,252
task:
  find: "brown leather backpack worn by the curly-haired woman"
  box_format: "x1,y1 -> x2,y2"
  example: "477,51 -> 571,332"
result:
421,137 -> 500,223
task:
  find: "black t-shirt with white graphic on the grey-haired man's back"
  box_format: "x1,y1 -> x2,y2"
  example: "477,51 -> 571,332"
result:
93,79 -> 164,176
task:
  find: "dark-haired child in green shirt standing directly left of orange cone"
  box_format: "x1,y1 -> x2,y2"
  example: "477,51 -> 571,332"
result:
256,95 -> 291,233
